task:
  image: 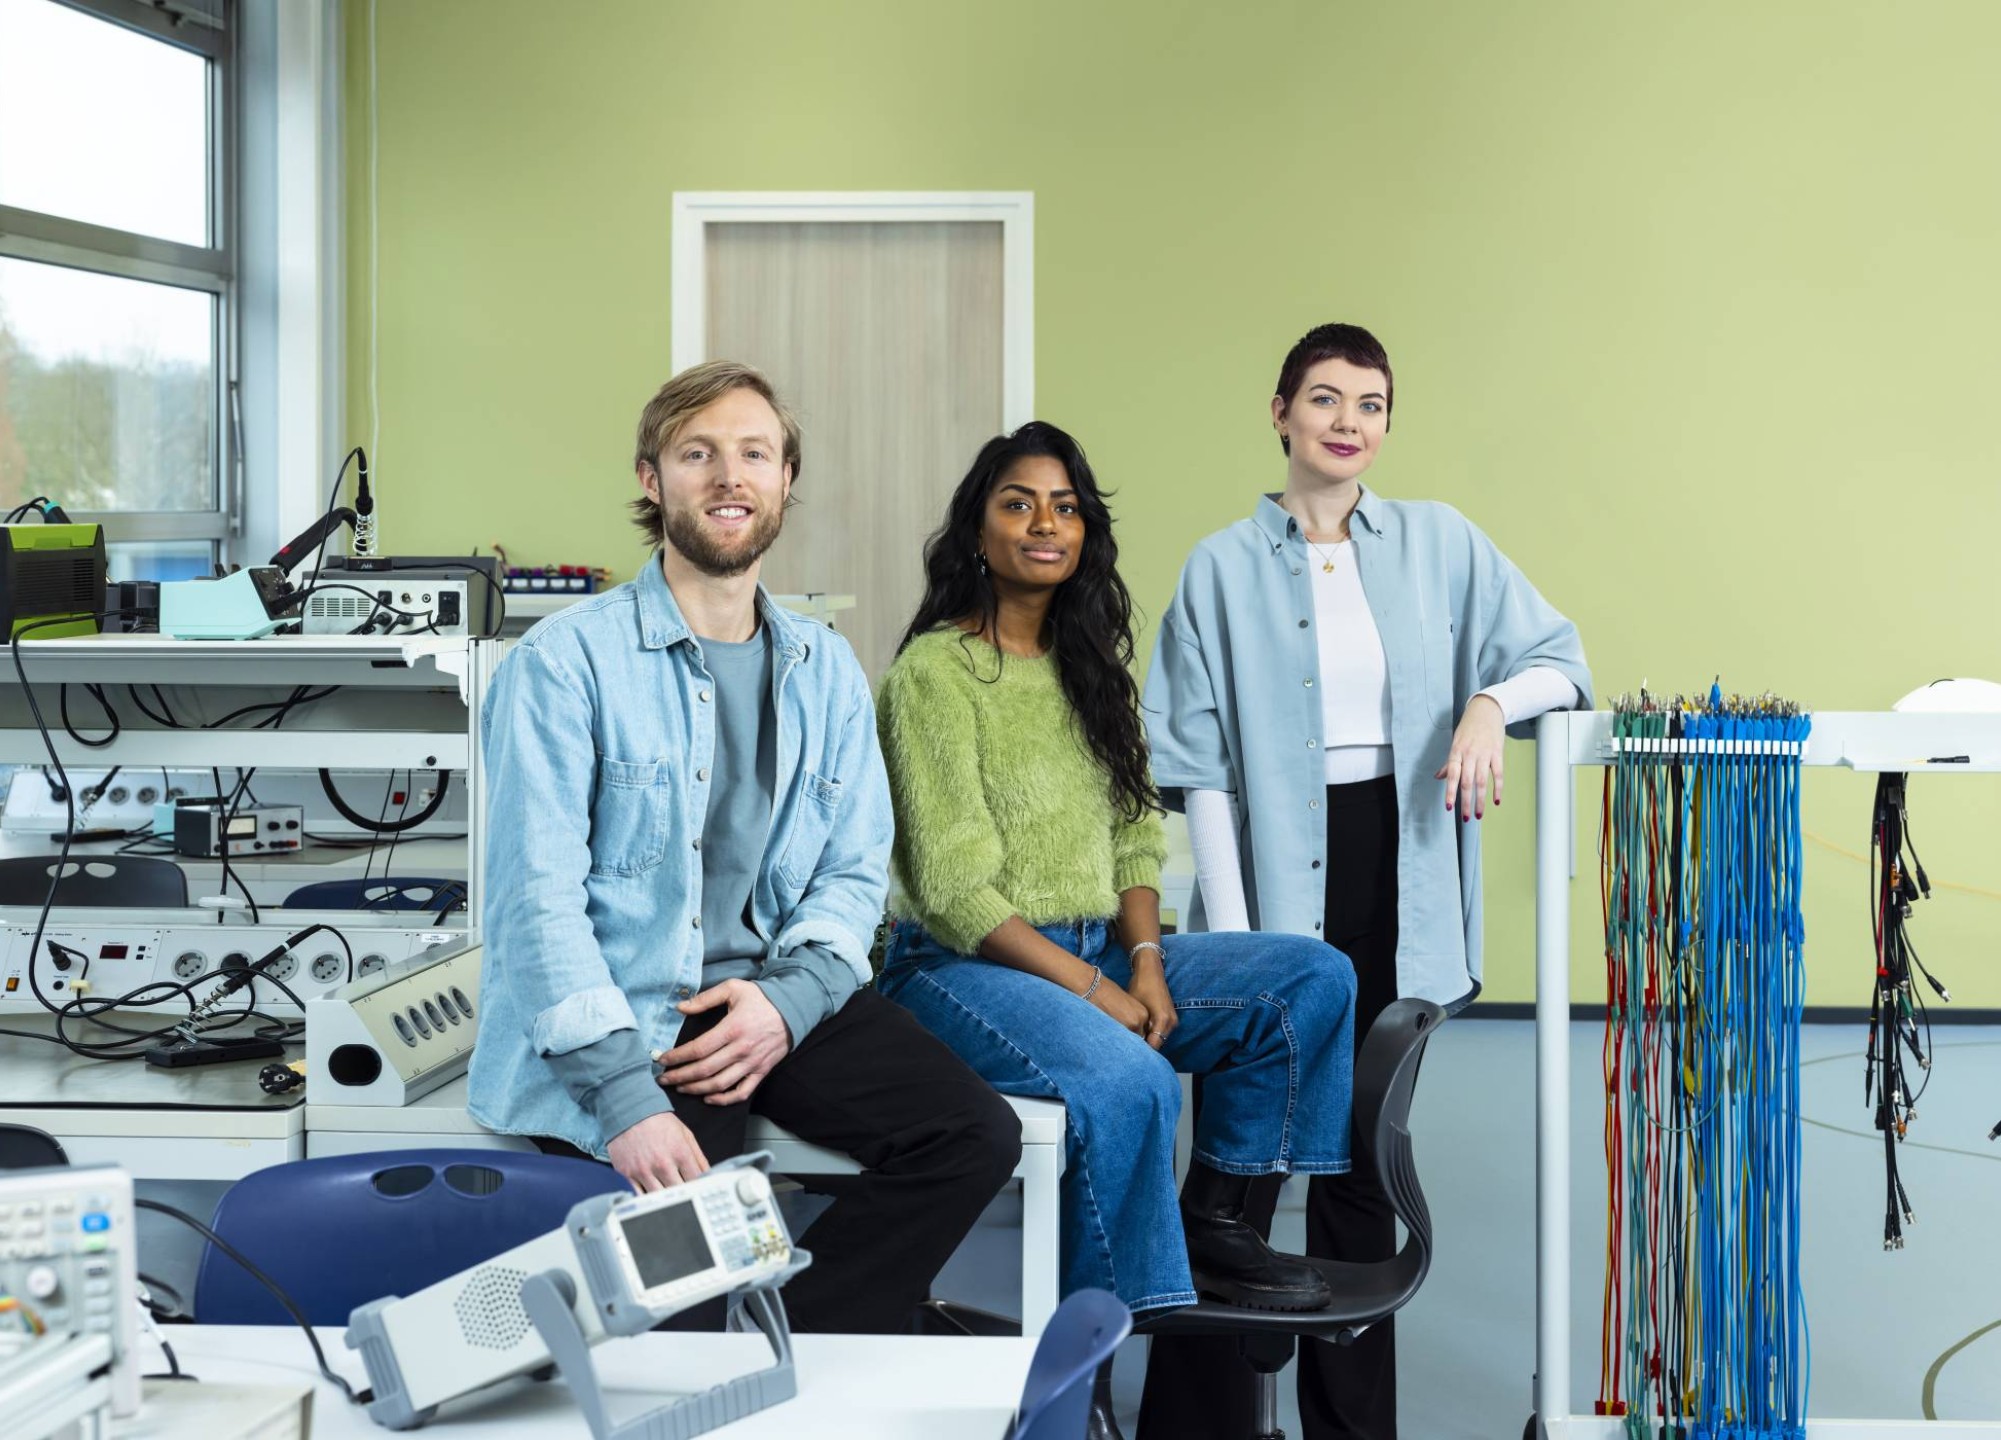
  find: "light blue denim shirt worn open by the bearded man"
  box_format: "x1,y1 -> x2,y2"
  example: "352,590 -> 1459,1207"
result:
466,560 -> 892,1154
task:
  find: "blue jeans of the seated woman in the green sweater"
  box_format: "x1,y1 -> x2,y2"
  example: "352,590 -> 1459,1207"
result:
876,920 -> 1355,1310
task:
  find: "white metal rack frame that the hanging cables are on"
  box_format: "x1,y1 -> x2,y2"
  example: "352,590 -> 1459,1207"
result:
1533,710 -> 2001,1440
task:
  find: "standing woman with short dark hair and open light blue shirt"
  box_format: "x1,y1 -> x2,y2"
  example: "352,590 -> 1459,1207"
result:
1141,324 -> 1591,1440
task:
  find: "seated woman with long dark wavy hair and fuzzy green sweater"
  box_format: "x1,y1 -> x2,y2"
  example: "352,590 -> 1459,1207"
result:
876,422 -> 1355,1432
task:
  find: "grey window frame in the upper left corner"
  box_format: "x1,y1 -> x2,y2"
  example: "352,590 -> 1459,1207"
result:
0,0 -> 244,558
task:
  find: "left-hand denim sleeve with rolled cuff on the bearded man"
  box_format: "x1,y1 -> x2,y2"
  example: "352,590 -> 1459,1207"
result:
482,644 -> 638,1056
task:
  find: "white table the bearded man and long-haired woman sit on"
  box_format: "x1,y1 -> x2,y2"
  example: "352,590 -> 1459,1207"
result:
306,1078 -> 1065,1336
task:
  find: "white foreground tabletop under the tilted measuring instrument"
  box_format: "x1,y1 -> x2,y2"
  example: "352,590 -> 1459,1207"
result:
142,1326 -> 1035,1440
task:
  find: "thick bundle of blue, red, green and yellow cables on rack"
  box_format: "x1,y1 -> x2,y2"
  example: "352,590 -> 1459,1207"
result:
1599,686 -> 1813,1440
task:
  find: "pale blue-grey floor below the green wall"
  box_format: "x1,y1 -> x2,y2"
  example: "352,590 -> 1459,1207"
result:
140,1020 -> 2001,1440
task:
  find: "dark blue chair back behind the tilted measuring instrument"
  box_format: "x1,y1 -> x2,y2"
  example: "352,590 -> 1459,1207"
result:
194,1150 -> 626,1326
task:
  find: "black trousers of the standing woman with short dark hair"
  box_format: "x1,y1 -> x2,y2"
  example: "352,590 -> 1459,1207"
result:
1139,776 -> 1397,1440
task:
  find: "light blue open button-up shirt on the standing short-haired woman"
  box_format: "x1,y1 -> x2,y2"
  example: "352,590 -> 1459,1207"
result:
1145,490 -> 1591,1008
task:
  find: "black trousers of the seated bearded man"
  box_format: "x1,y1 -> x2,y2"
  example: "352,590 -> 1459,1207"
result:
536,990 -> 1021,1334
